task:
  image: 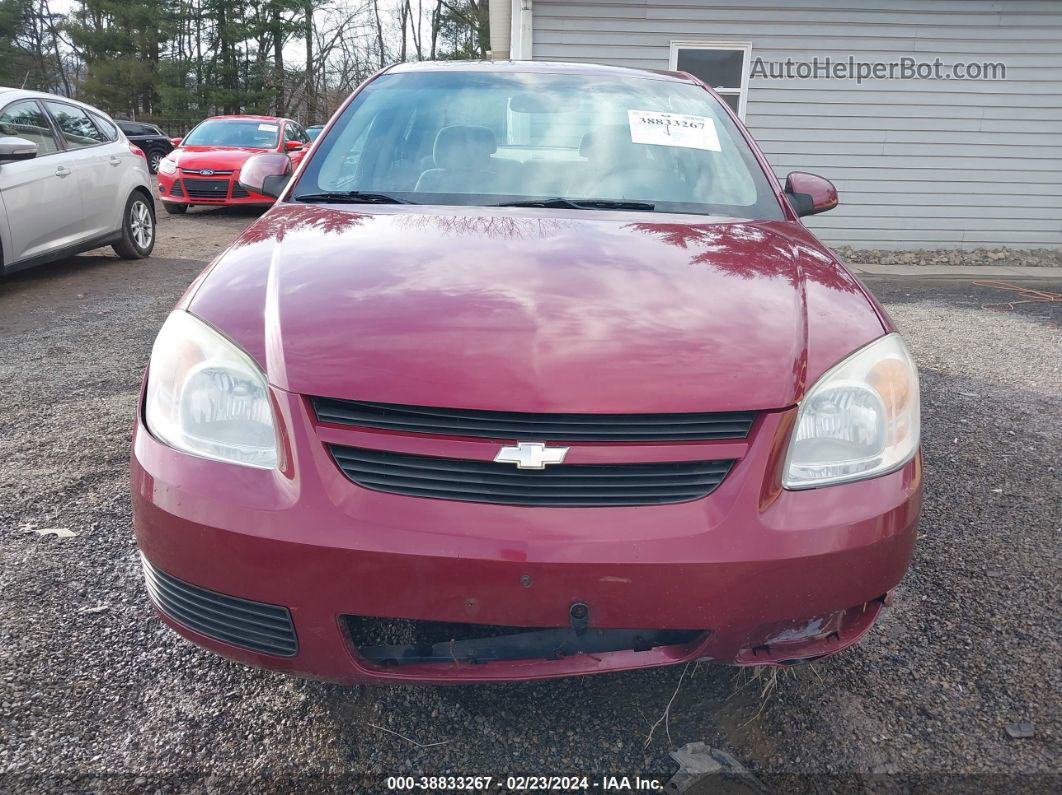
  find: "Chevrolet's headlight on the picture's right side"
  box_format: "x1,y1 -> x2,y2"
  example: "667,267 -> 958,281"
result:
783,334 -> 921,488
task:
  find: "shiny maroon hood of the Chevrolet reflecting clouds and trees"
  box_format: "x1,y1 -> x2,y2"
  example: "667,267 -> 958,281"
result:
183,204 -> 888,413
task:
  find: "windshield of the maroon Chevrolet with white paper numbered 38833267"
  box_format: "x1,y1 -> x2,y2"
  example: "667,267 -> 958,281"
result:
294,71 -> 782,219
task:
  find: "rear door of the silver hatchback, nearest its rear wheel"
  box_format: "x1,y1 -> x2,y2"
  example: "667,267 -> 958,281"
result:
45,100 -> 123,238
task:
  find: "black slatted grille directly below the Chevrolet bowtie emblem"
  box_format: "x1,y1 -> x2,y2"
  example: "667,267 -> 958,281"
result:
329,445 -> 734,506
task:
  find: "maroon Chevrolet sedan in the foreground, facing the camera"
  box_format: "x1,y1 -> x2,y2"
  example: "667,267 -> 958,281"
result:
132,63 -> 922,682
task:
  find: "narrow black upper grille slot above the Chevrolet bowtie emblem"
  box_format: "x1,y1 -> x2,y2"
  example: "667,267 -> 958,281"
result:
313,398 -> 756,442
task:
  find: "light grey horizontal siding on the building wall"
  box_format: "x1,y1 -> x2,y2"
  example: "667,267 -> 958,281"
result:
532,0 -> 1062,248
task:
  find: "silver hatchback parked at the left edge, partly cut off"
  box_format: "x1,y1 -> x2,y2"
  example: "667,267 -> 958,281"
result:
0,87 -> 155,273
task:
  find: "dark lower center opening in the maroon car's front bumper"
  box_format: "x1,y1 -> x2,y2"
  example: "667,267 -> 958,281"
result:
344,616 -> 707,667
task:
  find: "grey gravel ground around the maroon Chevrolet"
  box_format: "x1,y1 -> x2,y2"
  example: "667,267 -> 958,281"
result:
0,205 -> 1062,792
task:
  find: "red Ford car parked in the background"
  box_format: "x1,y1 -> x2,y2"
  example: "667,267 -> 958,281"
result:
158,116 -> 311,214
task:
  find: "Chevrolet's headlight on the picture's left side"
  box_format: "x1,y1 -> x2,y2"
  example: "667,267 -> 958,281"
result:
144,310 -> 277,469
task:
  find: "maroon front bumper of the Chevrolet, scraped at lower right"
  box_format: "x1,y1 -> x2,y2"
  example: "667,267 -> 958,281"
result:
132,390 -> 922,682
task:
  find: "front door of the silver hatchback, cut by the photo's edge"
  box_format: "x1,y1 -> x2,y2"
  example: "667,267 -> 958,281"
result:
0,99 -> 89,265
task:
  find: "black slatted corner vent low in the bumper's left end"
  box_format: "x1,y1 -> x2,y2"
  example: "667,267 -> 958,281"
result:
140,555 -> 298,657
